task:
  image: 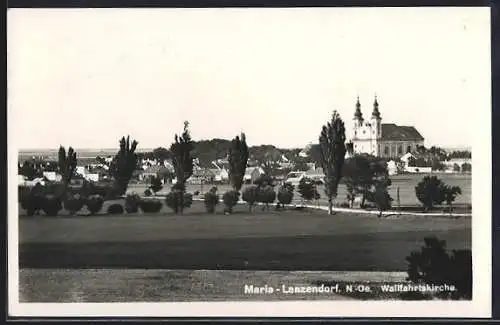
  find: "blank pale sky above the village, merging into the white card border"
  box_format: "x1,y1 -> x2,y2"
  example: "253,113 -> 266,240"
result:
7,7 -> 491,149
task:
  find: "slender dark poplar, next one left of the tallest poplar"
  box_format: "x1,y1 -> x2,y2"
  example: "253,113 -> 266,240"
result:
229,133 -> 249,192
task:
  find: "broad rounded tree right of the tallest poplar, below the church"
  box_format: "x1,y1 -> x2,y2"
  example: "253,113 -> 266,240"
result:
342,154 -> 391,207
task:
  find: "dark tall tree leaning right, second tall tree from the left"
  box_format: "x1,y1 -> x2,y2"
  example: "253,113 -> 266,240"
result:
110,136 -> 139,195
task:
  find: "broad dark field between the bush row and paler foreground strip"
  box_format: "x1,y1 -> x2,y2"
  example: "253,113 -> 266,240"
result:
19,203 -> 471,271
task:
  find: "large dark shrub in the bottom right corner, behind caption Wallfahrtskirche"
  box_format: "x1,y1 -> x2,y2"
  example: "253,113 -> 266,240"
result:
406,237 -> 472,299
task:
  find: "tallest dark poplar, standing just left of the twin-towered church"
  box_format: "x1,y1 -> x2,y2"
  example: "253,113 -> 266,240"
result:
319,111 -> 347,214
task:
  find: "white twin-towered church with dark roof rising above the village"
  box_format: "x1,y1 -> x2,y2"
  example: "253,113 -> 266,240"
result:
351,96 -> 424,158
